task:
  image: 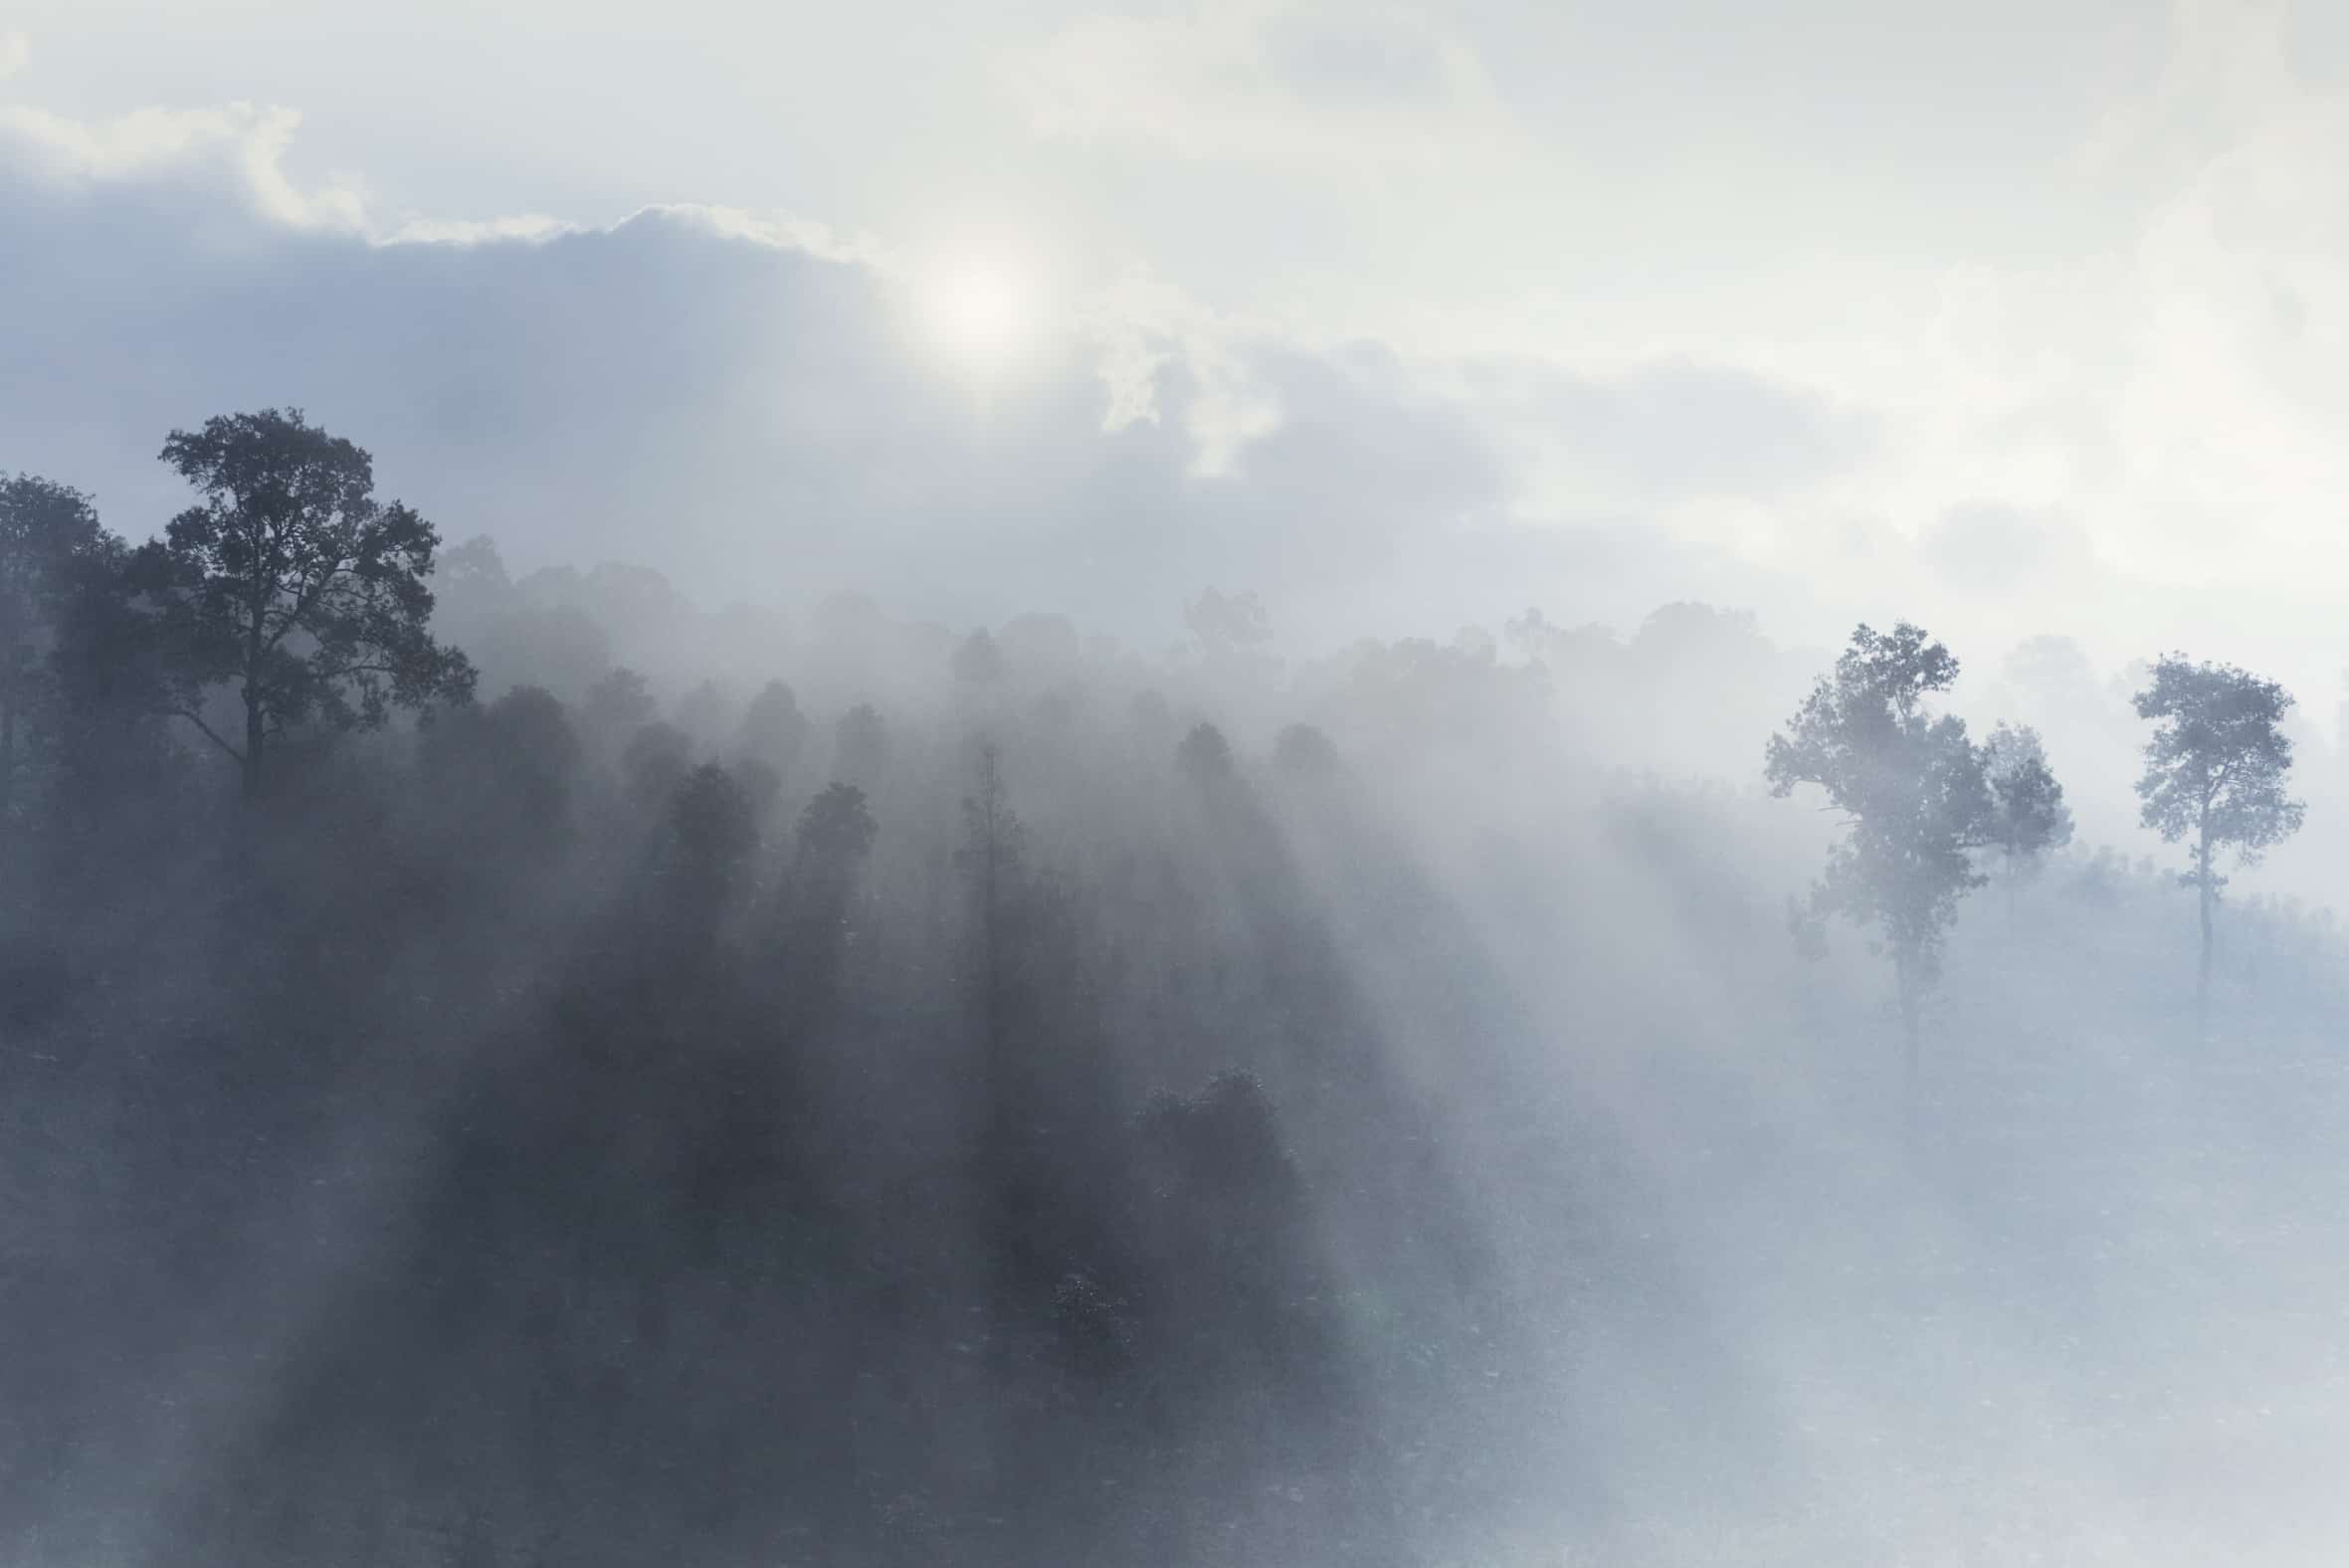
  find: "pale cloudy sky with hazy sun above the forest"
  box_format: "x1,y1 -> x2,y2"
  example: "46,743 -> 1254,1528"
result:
0,0 -> 2349,720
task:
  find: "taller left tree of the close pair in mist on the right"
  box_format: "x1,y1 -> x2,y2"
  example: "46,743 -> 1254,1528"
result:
1764,622 -> 1994,1091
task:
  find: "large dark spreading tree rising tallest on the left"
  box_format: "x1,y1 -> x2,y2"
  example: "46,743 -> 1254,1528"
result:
148,409 -> 475,798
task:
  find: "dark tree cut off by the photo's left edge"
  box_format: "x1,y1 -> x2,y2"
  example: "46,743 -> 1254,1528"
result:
0,475 -> 112,824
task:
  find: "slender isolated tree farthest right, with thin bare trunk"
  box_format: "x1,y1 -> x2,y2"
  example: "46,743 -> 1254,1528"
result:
2133,653 -> 2307,1028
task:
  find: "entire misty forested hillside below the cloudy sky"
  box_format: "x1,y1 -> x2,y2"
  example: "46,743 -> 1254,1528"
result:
0,409 -> 2349,1568
